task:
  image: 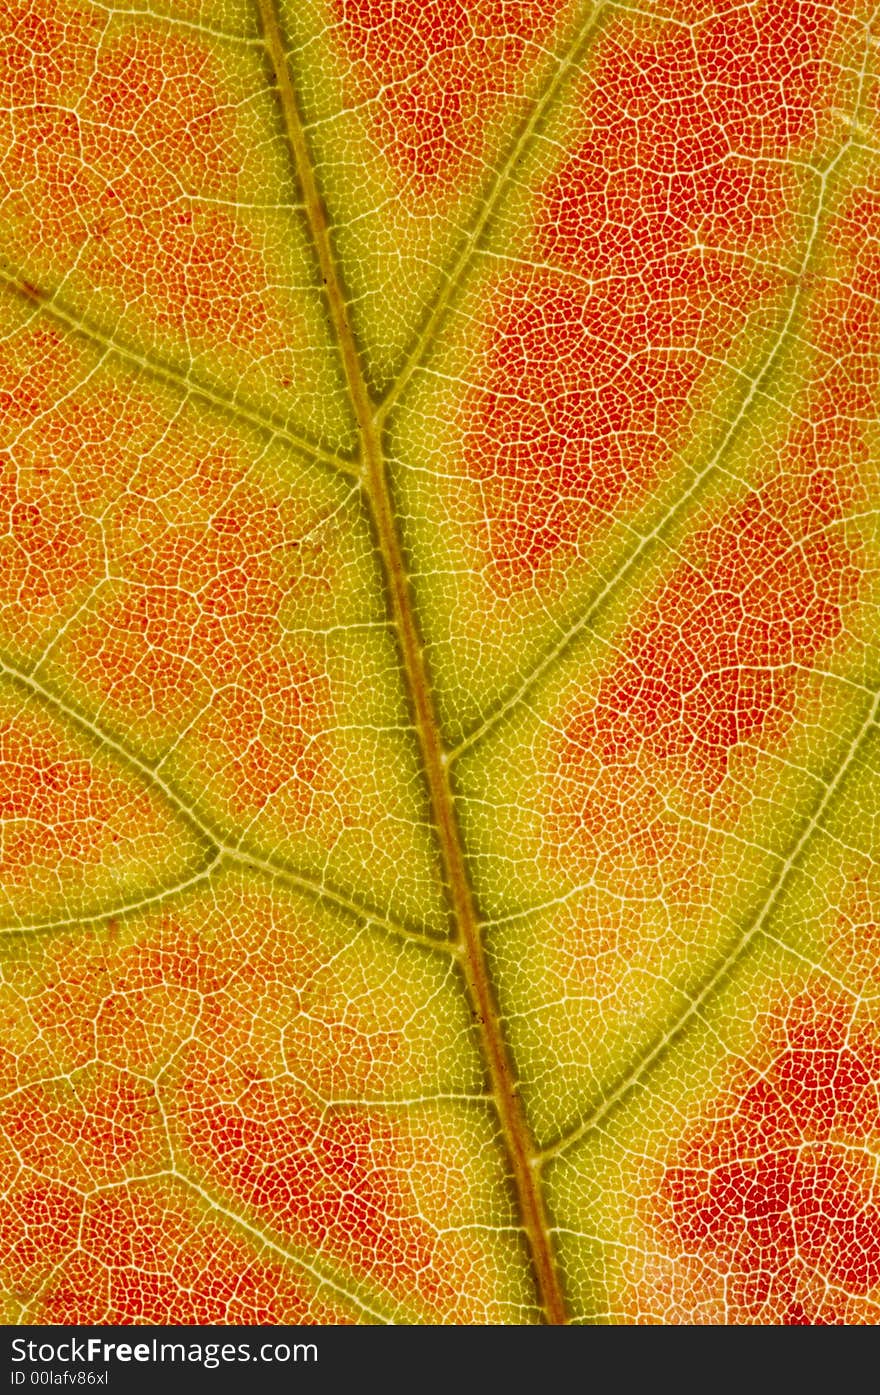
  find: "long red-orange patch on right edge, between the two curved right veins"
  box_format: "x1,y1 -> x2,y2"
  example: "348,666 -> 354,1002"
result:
551,175 -> 880,847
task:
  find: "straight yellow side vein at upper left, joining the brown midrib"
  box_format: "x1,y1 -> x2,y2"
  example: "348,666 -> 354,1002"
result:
0,268 -> 357,478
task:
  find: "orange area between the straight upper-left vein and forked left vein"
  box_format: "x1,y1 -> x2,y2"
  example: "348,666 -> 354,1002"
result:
0,326 -> 365,837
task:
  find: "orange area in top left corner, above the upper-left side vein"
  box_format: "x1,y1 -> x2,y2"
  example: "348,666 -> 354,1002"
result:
0,0 -> 290,364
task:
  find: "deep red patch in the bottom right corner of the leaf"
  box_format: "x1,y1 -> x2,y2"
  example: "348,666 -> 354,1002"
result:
660,996 -> 880,1325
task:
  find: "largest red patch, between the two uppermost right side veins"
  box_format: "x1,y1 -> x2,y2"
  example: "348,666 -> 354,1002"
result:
464,3 -> 834,594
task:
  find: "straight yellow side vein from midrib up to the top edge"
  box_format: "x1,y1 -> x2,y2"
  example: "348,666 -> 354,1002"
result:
377,0 -> 602,421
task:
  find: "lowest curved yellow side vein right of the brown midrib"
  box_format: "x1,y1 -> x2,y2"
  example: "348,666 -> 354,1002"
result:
541,680 -> 880,1162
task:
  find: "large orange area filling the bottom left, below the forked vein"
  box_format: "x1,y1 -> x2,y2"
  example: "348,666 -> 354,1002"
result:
0,880 -> 510,1322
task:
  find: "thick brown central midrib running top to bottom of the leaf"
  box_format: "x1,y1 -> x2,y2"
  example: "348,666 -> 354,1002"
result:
257,0 -> 566,1324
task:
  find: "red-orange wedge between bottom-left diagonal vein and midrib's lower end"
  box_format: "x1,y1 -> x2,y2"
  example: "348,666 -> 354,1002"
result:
180,1050 -> 483,1322
